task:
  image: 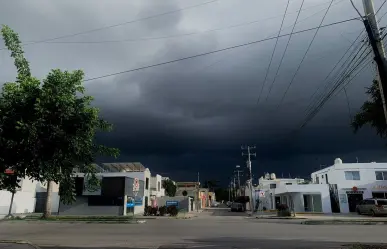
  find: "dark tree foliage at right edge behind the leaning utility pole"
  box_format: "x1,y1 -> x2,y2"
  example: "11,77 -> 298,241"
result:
351,80 -> 387,138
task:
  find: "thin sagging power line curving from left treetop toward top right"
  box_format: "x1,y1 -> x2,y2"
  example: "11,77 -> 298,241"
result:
23,0 -> 344,44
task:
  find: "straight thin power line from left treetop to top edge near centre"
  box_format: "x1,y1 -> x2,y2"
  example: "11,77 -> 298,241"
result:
0,0 -> 218,50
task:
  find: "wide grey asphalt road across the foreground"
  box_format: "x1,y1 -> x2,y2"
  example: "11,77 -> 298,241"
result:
0,209 -> 387,249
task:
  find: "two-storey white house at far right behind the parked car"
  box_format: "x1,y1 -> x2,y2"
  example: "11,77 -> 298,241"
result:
311,158 -> 387,213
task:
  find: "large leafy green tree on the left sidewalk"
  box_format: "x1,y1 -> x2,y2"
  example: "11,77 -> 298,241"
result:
0,26 -> 119,217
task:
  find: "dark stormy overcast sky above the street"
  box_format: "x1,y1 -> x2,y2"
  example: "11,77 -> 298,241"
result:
0,0 -> 387,182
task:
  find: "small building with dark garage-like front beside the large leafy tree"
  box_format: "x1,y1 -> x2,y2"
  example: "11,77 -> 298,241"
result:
59,163 -> 151,215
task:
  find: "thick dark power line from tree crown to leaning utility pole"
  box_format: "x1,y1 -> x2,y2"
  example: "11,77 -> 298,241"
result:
84,18 -> 358,81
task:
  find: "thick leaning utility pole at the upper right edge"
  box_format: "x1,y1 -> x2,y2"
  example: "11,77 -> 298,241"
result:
363,0 -> 387,123
